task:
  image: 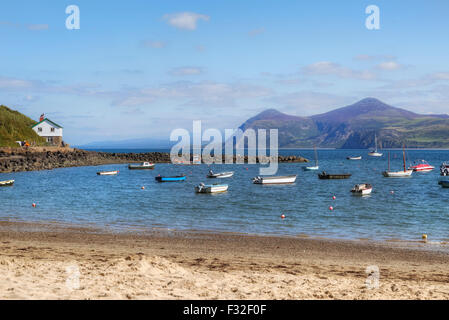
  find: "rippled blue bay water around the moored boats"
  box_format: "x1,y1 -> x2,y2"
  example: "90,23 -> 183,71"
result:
0,150 -> 449,241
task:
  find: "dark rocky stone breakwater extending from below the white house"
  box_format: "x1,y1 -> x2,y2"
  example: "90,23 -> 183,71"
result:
0,149 -> 308,172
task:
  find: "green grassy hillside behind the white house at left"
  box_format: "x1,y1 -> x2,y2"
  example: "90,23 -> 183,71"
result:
0,105 -> 46,147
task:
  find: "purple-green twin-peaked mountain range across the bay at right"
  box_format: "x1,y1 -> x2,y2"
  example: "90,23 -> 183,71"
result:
240,98 -> 449,149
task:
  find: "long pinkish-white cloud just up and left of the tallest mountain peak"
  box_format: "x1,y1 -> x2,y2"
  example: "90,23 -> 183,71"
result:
302,61 -> 376,80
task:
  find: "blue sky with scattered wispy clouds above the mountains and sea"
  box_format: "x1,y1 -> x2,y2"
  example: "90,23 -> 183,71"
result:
0,0 -> 449,145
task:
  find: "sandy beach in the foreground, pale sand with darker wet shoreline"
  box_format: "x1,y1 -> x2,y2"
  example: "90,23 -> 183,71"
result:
0,222 -> 449,299
